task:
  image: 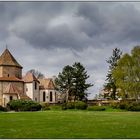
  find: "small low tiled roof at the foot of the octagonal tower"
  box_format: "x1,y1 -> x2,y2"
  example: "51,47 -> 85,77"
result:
4,83 -> 21,94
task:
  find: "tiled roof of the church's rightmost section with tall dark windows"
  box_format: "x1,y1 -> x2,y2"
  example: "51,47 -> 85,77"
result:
39,78 -> 55,89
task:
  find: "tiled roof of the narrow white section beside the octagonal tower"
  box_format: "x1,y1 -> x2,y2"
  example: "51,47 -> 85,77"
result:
23,72 -> 39,83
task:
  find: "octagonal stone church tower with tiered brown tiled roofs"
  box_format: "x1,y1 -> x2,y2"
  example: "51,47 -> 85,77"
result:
0,49 -> 25,106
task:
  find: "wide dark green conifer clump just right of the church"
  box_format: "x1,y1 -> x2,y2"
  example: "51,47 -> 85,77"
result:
56,63 -> 92,102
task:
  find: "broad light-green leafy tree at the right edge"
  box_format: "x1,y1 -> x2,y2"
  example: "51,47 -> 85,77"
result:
113,46 -> 140,99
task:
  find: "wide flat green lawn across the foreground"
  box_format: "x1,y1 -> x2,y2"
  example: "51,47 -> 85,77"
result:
0,110 -> 140,138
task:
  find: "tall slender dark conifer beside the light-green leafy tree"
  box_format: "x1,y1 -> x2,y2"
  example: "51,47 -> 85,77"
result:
104,48 -> 122,99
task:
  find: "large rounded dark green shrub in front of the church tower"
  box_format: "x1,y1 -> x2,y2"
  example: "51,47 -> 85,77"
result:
7,100 -> 41,111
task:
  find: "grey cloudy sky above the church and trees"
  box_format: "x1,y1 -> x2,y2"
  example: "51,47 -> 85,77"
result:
0,2 -> 140,98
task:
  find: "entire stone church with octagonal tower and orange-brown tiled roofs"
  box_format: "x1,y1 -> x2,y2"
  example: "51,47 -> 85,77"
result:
0,49 -> 59,106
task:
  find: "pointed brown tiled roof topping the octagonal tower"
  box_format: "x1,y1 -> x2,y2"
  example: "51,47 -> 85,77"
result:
0,49 -> 22,68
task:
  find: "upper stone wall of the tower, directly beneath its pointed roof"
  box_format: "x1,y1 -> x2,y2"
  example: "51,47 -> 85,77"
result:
0,66 -> 22,79
